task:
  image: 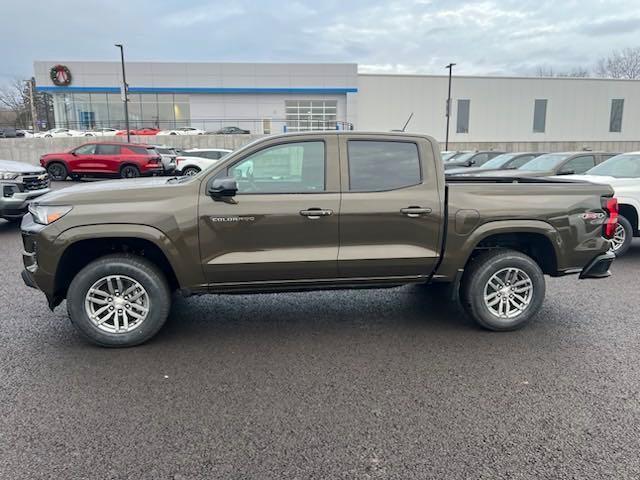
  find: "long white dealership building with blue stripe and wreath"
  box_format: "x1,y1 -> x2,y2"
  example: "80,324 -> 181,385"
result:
34,60 -> 640,143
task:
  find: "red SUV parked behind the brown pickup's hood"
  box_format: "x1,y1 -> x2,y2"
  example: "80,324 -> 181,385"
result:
40,142 -> 163,181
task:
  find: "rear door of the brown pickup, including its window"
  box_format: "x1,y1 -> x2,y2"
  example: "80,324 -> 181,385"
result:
338,134 -> 444,278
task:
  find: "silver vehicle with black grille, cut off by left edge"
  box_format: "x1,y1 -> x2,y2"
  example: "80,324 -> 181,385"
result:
0,160 -> 51,222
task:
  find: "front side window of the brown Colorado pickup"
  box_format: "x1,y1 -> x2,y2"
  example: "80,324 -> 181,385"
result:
228,142 -> 325,193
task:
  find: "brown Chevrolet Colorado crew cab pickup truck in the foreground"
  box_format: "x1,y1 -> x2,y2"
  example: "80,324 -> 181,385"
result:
22,131 -> 617,347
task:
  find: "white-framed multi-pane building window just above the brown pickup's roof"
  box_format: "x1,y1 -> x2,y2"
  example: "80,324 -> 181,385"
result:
284,100 -> 338,132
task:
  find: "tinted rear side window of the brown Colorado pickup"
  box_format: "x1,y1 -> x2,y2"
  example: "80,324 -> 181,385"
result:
347,140 -> 422,192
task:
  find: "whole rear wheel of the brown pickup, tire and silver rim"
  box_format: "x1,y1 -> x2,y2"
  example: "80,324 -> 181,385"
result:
460,249 -> 545,331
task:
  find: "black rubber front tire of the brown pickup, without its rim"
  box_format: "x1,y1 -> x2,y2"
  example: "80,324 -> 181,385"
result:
67,254 -> 171,347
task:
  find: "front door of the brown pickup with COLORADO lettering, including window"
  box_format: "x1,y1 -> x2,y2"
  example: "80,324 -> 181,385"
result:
199,135 -> 340,286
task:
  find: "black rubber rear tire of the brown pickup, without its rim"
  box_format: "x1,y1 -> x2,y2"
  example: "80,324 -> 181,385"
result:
460,249 -> 545,332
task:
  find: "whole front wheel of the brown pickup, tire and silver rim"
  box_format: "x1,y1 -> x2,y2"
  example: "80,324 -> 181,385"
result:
67,254 -> 171,347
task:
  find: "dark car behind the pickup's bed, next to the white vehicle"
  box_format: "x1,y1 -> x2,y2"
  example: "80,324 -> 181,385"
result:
474,151 -> 617,177
